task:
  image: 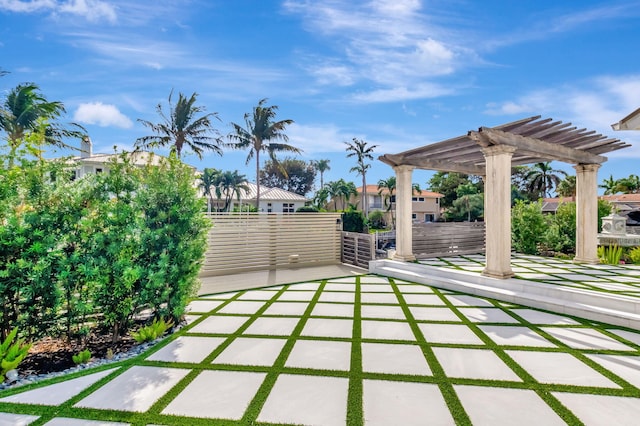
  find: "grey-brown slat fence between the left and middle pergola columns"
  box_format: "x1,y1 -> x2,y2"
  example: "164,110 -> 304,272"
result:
413,222 -> 485,259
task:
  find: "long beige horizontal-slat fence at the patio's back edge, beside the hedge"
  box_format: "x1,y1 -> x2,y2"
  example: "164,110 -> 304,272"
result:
200,213 -> 341,276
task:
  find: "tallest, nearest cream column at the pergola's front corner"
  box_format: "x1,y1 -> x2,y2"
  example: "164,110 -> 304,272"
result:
482,145 -> 516,278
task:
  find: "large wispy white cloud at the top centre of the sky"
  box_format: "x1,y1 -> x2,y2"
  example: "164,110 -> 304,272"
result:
284,0 -> 478,102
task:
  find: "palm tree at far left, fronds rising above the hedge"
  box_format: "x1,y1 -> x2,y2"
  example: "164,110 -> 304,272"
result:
0,83 -> 86,158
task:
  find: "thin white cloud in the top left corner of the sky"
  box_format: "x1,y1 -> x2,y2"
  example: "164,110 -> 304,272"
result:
0,0 -> 117,23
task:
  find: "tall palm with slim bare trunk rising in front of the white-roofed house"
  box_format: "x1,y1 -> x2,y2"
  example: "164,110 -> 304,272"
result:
229,98 -> 302,209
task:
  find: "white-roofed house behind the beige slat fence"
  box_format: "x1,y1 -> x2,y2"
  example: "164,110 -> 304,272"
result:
206,182 -> 309,213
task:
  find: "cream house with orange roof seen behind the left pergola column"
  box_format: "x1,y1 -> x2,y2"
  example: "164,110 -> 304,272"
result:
349,185 -> 444,222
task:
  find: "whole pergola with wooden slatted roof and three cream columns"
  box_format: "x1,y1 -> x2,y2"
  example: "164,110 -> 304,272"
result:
380,116 -> 630,278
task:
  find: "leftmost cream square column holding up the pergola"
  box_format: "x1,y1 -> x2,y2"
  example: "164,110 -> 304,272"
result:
393,166 -> 416,262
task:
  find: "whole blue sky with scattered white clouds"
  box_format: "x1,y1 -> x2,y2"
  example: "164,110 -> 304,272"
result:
0,0 -> 640,195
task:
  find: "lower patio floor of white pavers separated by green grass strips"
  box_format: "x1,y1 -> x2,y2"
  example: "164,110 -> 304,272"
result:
0,265 -> 640,425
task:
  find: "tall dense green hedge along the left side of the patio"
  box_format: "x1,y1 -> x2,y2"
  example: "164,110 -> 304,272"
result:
0,148 -> 209,378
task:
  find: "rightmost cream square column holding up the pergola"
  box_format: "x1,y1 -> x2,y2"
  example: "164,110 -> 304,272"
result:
573,164 -> 600,263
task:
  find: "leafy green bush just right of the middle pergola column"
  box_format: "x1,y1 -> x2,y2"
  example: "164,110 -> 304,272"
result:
511,200 -> 547,254
